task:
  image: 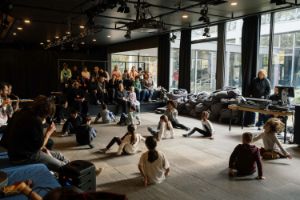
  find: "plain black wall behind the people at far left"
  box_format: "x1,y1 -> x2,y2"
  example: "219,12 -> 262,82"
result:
0,47 -> 107,98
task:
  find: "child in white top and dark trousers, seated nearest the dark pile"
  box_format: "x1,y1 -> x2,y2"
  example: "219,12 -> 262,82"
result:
183,111 -> 214,139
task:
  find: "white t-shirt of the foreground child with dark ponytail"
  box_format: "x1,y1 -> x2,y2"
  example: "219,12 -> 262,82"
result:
139,151 -> 170,183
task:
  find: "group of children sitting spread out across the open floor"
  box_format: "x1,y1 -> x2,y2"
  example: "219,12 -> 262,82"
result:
58,98 -> 292,185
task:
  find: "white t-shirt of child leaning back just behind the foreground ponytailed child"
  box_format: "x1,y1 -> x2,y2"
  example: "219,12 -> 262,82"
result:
117,134 -> 145,155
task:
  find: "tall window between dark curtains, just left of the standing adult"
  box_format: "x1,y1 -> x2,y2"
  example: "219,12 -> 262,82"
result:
225,20 -> 243,88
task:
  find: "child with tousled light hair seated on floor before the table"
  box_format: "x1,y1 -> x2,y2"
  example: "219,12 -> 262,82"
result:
253,118 -> 292,159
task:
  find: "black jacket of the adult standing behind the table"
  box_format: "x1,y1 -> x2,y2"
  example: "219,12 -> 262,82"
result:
250,78 -> 271,99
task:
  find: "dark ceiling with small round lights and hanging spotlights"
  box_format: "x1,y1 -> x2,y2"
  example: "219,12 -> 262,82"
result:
1,0 -> 298,45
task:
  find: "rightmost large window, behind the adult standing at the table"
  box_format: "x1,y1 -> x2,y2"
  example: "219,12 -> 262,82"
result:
258,8 -> 300,103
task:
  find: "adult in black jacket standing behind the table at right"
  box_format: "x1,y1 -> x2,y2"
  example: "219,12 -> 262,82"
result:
250,69 -> 271,128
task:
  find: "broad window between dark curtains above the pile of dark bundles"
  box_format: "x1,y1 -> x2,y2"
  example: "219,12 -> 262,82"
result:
191,41 -> 217,93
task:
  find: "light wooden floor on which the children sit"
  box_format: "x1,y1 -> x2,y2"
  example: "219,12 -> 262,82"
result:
54,113 -> 300,200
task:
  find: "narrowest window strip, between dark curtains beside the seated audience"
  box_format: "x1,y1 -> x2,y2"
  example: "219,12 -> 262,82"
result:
169,32 -> 181,89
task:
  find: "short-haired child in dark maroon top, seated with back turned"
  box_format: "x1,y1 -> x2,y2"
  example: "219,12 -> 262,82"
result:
228,133 -> 264,179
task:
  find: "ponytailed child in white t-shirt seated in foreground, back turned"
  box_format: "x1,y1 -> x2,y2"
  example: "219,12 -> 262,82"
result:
138,136 -> 170,186
